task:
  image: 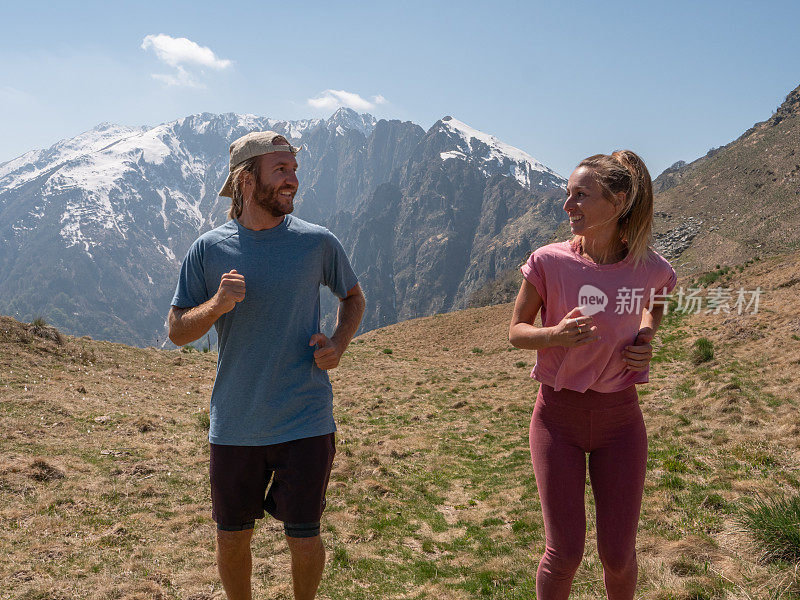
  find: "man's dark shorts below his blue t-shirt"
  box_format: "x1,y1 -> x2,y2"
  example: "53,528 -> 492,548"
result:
210,433 -> 336,537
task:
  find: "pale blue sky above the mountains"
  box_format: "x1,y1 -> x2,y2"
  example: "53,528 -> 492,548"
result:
0,0 -> 800,176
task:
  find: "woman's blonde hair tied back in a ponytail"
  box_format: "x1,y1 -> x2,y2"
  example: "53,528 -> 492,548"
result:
570,150 -> 653,266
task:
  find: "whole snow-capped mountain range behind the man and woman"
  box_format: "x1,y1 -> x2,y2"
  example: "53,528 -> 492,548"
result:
0,108 -> 564,344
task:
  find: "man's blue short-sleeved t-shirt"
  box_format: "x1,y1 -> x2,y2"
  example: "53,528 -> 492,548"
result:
172,215 -> 358,446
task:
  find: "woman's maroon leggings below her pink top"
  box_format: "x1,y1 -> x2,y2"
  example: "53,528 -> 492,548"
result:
530,384 -> 647,600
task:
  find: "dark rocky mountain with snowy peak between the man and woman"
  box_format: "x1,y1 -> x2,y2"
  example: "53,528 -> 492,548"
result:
331,117 -> 564,330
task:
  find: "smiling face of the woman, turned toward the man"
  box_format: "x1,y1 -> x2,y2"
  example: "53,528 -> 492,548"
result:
564,167 -> 624,238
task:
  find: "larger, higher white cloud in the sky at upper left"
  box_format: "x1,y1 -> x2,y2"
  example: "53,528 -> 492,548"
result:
140,33 -> 233,87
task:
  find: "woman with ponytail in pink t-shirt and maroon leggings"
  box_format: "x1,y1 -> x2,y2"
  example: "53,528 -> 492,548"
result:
509,150 -> 676,600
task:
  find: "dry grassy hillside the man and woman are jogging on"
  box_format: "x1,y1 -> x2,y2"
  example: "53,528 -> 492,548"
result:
0,251 -> 800,600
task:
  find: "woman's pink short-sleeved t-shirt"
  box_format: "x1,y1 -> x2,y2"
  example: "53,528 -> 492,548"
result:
521,241 -> 677,392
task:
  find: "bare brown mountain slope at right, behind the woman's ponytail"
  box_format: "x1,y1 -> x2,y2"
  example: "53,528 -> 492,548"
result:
654,87 -> 800,272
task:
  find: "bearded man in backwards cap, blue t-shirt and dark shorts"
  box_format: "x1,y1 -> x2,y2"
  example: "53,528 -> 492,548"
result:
169,131 -> 364,600
